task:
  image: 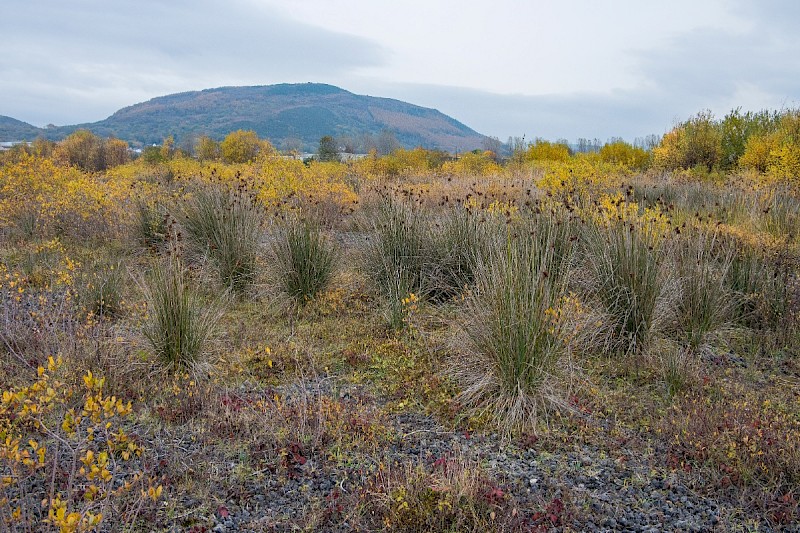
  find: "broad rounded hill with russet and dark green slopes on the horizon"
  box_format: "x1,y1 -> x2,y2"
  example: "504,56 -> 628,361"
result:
0,83 -> 484,152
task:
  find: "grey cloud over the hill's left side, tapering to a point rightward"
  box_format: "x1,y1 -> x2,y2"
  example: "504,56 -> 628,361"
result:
0,0 -> 387,124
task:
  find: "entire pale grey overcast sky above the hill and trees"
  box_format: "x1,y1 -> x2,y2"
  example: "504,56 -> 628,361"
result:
0,0 -> 800,141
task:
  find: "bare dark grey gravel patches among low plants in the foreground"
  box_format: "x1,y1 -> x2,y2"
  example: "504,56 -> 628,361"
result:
183,404 -> 800,532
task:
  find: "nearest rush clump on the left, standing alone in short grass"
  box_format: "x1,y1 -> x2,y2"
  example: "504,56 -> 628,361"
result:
144,255 -> 216,369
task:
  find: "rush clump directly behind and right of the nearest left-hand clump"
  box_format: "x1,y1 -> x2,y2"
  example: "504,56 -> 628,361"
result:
183,186 -> 263,295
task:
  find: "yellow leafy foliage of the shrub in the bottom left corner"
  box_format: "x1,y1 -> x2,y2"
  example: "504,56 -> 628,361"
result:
0,357 -> 162,533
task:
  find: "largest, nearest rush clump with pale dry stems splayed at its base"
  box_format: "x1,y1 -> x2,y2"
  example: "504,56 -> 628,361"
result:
453,210 -> 571,432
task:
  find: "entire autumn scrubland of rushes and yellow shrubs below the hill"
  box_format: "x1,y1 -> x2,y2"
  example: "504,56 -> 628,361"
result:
0,111 -> 800,532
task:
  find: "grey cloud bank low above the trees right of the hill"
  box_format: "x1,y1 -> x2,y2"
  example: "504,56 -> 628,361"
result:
383,0 -> 800,140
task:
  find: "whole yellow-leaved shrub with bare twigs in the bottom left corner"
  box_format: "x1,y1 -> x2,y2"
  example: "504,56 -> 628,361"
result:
0,357 -> 163,532
